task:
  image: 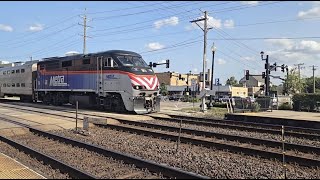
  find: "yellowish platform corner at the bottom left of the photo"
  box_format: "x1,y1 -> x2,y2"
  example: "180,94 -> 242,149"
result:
0,153 -> 46,179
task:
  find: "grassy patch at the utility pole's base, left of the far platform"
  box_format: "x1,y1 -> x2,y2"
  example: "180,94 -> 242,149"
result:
181,107 -> 228,119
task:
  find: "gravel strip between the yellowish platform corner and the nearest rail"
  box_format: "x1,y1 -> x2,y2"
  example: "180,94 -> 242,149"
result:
0,142 -> 70,179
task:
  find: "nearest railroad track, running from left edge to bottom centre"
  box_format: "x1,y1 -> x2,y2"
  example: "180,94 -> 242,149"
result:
1,118 -> 208,179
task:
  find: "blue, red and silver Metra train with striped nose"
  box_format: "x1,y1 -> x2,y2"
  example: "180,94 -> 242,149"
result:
0,50 -> 160,114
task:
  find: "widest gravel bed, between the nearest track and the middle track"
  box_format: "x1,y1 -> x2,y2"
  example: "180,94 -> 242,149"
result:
51,127 -> 320,179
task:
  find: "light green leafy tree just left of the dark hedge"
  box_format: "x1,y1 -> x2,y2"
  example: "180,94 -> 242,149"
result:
283,69 -> 306,94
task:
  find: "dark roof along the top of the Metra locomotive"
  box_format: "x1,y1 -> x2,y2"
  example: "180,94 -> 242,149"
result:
40,50 -> 141,63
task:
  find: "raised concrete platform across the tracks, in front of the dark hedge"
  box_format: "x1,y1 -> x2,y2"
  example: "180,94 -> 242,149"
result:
226,110 -> 320,129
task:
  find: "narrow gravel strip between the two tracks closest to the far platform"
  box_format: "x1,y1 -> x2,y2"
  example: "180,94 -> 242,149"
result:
141,120 -> 320,147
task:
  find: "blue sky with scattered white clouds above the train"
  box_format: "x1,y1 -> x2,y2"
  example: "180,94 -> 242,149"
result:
0,1 -> 320,84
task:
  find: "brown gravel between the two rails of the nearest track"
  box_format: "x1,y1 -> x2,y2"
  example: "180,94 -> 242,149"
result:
14,133 -> 161,179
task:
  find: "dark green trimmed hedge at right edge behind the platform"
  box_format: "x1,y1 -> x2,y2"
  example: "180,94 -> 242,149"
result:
292,93 -> 320,111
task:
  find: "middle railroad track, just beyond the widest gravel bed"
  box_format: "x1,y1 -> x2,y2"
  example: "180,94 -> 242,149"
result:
94,120 -> 320,167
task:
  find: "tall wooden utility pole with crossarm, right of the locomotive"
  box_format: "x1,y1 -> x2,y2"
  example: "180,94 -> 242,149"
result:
190,11 -> 212,112
